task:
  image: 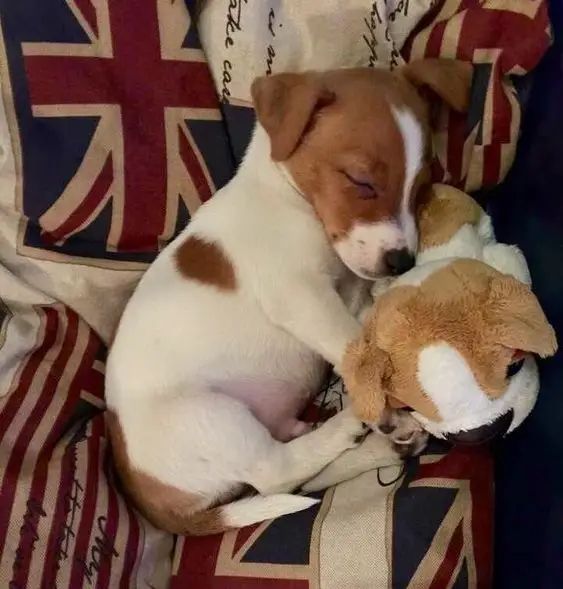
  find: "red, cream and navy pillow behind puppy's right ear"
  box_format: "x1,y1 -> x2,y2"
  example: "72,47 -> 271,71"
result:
402,0 -> 551,192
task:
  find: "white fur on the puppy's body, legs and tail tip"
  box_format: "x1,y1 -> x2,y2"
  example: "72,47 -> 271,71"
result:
106,126 -> 406,525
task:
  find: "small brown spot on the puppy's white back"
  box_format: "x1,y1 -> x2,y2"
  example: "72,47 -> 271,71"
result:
176,235 -> 237,290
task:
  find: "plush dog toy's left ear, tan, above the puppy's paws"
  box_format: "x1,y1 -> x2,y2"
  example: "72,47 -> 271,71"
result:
342,338 -> 390,423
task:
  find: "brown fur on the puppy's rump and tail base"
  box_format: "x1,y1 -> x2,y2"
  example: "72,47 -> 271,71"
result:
106,411 -> 234,536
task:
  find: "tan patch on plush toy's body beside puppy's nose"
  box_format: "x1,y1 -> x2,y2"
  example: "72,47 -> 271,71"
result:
417,184 -> 484,251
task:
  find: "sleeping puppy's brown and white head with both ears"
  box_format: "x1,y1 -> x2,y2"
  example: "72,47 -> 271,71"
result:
252,60 -> 472,278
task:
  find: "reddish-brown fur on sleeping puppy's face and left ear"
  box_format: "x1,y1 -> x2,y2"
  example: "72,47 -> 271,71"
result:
253,65 -> 470,241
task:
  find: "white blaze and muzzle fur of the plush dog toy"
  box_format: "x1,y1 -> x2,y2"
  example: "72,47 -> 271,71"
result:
415,342 -> 538,437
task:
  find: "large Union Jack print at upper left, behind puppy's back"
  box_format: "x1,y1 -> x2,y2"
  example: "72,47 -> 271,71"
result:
0,0 -> 233,265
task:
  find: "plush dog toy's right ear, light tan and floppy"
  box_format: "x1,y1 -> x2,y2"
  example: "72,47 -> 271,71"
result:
486,274 -> 557,358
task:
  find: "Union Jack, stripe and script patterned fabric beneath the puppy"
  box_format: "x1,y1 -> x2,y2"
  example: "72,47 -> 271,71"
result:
0,0 -> 549,589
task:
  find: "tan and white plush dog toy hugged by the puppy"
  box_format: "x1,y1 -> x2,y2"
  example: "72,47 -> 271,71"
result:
343,185 -> 557,444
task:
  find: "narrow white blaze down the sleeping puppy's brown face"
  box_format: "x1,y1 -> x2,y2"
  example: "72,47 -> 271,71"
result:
391,107 -> 424,251
